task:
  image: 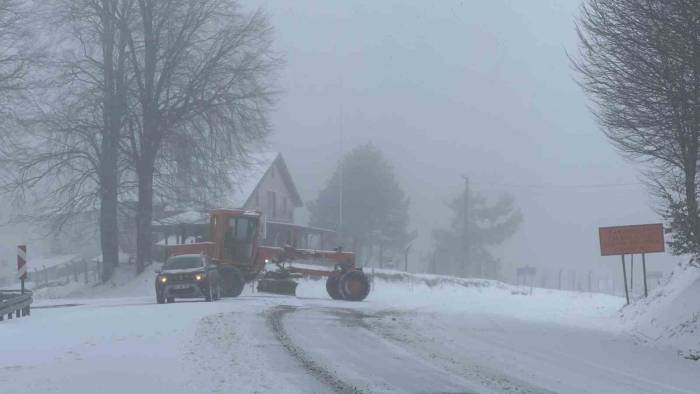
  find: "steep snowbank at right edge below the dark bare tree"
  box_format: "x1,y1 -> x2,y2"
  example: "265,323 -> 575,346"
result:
622,264 -> 700,358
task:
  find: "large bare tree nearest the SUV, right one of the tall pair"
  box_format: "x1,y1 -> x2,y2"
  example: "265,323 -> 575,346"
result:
121,0 -> 279,271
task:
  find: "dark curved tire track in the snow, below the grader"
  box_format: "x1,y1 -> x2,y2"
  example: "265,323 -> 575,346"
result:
268,305 -> 364,394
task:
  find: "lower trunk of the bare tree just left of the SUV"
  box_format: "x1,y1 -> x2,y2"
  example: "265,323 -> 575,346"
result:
136,158 -> 154,273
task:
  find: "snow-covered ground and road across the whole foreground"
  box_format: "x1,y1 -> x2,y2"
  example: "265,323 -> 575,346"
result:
0,266 -> 700,393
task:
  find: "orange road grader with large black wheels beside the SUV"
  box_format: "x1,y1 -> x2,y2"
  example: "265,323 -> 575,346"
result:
168,209 -> 370,301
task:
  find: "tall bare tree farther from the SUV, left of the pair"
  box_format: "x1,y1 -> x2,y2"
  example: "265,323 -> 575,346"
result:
2,0 -> 133,280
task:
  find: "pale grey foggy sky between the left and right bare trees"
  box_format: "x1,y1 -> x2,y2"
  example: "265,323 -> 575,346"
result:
254,0 -> 678,276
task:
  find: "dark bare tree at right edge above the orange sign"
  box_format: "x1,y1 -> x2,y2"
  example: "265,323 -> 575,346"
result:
573,0 -> 700,264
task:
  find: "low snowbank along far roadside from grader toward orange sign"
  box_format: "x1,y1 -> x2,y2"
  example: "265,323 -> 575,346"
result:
297,270 -> 624,332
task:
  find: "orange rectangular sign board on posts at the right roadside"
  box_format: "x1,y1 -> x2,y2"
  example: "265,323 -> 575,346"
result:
598,223 -> 665,256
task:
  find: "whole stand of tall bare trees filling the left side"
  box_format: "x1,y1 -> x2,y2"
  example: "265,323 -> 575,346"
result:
0,0 -> 281,280
